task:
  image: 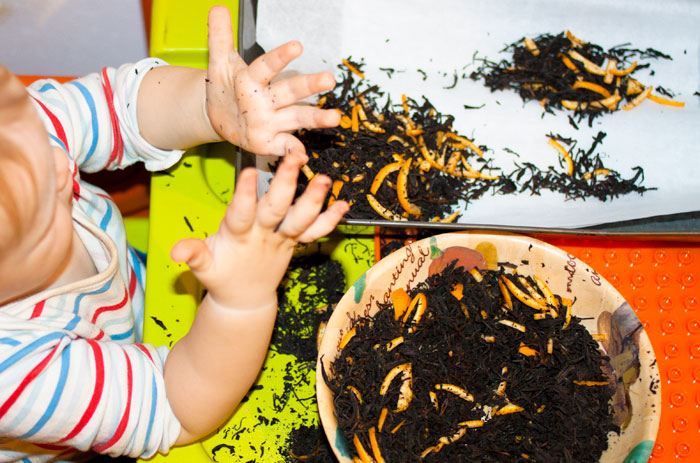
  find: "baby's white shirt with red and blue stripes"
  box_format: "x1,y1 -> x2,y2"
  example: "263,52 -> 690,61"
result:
0,58 -> 182,462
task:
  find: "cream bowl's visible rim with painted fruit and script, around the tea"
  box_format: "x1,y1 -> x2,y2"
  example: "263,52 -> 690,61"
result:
316,233 -> 661,463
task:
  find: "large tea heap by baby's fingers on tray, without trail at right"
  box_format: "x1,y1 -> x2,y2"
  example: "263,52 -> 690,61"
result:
296,58 -> 503,222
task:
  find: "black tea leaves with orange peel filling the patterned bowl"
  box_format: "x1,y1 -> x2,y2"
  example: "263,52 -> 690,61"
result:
322,263 -> 619,463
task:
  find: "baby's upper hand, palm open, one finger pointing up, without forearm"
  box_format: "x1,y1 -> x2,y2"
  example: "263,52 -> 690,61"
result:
202,6 -> 340,156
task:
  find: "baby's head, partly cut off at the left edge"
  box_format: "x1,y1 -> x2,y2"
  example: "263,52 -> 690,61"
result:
0,66 -> 73,305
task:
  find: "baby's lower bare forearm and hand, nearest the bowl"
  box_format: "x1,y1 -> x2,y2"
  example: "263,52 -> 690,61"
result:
165,153 -> 348,443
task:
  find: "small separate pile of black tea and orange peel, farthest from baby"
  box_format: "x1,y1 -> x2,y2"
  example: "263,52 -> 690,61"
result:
470,31 -> 684,126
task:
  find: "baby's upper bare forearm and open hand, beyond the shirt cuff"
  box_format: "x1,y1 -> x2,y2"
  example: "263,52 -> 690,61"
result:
137,6 -> 340,156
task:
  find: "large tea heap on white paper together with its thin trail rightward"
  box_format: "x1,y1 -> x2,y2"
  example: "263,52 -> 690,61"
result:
272,58 -> 648,222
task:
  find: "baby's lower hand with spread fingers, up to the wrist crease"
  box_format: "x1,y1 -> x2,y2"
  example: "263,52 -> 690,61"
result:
171,153 -> 348,309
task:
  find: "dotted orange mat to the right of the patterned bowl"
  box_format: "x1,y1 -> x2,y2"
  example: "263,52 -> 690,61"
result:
537,236 -> 700,463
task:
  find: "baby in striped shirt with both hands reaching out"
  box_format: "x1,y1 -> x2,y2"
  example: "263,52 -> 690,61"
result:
0,7 -> 348,462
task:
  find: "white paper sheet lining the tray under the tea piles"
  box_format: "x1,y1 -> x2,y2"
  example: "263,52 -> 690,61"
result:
256,0 -> 700,227
